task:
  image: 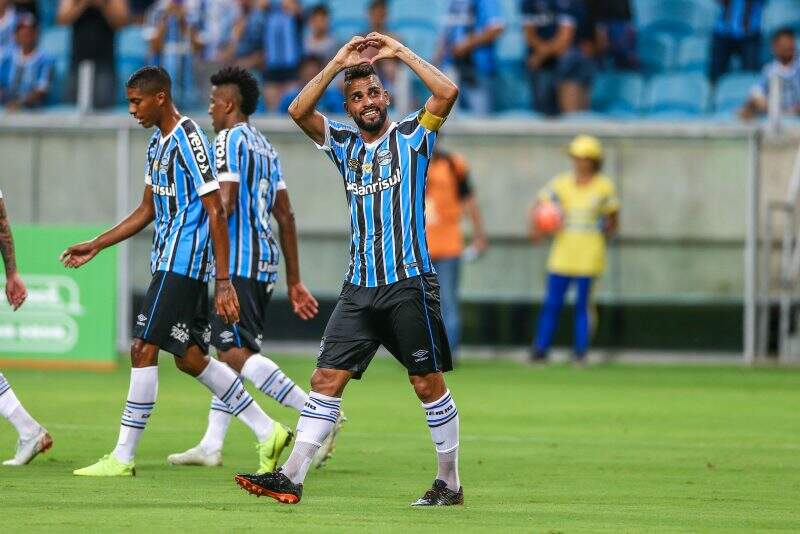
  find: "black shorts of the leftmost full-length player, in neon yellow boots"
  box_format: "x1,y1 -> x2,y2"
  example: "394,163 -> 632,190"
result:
133,271 -> 211,356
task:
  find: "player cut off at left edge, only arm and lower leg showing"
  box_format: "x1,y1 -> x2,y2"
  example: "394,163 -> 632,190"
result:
0,191 -> 53,465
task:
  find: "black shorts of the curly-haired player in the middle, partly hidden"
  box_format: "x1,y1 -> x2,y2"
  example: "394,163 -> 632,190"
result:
211,276 -> 275,352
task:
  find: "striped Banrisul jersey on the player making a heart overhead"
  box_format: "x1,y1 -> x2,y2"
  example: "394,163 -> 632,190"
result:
317,109 -> 442,287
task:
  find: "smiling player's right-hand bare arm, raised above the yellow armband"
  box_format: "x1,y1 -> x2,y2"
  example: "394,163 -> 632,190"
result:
364,32 -> 458,119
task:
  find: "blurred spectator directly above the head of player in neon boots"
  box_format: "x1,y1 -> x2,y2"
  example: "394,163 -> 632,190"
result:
145,0 -> 195,108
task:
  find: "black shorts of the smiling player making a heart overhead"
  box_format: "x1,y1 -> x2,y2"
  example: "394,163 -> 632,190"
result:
317,274 -> 453,379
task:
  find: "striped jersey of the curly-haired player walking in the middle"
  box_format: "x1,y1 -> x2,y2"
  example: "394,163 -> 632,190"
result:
214,122 -> 286,282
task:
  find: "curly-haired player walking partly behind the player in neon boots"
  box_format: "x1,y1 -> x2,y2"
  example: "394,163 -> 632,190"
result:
167,67 -> 342,474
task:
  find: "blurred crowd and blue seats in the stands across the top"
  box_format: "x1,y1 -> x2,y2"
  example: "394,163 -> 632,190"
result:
0,0 -> 800,118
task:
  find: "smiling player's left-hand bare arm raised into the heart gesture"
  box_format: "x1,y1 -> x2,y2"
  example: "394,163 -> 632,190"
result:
289,35 -> 369,145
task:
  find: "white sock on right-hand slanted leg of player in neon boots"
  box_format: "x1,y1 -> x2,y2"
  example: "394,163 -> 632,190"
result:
197,358 -> 274,443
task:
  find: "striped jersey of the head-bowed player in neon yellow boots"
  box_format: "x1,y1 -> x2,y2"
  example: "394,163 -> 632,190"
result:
145,117 -> 219,281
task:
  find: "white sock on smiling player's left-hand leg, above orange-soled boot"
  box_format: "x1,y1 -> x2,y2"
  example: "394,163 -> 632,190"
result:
281,391 -> 342,484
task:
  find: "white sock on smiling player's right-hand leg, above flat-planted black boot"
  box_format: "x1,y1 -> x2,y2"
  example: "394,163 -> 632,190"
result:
422,389 -> 461,491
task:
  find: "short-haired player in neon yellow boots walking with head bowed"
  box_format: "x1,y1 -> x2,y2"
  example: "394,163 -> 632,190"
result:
62,66 -> 291,477
